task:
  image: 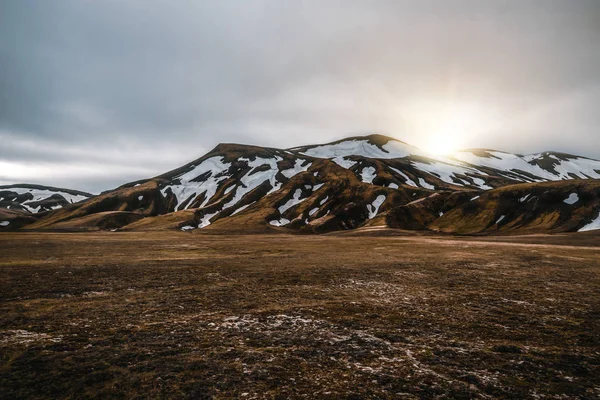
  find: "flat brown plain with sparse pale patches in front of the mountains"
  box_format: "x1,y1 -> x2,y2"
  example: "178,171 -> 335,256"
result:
0,232 -> 600,399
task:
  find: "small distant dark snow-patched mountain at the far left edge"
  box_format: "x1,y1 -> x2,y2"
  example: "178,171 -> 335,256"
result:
0,184 -> 92,213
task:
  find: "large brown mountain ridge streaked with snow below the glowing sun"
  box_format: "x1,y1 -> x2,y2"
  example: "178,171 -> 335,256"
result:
9,135 -> 600,234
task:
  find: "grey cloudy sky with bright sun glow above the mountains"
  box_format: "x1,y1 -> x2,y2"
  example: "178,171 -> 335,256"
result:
0,0 -> 600,193
